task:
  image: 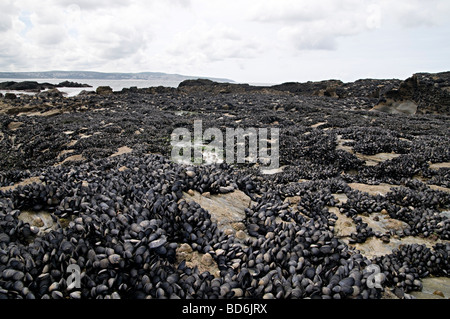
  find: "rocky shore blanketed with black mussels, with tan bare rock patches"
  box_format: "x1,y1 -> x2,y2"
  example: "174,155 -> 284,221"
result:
0,72 -> 450,299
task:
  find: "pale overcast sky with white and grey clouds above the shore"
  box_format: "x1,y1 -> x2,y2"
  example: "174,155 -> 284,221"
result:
0,0 -> 450,84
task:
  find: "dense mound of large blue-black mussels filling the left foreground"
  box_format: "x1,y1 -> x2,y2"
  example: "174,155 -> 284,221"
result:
0,155 -> 379,298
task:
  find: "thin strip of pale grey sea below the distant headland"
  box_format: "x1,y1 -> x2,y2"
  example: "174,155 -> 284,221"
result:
0,78 -> 273,97
